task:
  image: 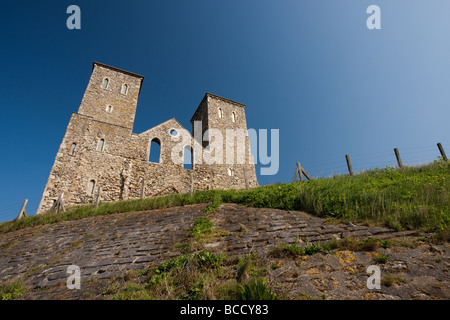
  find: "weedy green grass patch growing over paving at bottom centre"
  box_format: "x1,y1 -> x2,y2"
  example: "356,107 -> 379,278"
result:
102,251 -> 279,300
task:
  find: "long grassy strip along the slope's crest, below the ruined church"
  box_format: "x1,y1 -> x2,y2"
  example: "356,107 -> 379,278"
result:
0,161 -> 450,232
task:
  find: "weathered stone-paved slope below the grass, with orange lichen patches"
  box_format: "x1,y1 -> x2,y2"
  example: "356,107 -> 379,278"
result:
0,203 -> 450,300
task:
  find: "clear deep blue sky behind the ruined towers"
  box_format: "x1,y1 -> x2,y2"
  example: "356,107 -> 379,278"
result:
0,0 -> 450,221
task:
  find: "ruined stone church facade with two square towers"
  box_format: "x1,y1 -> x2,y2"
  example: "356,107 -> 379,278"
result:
37,62 -> 258,214
